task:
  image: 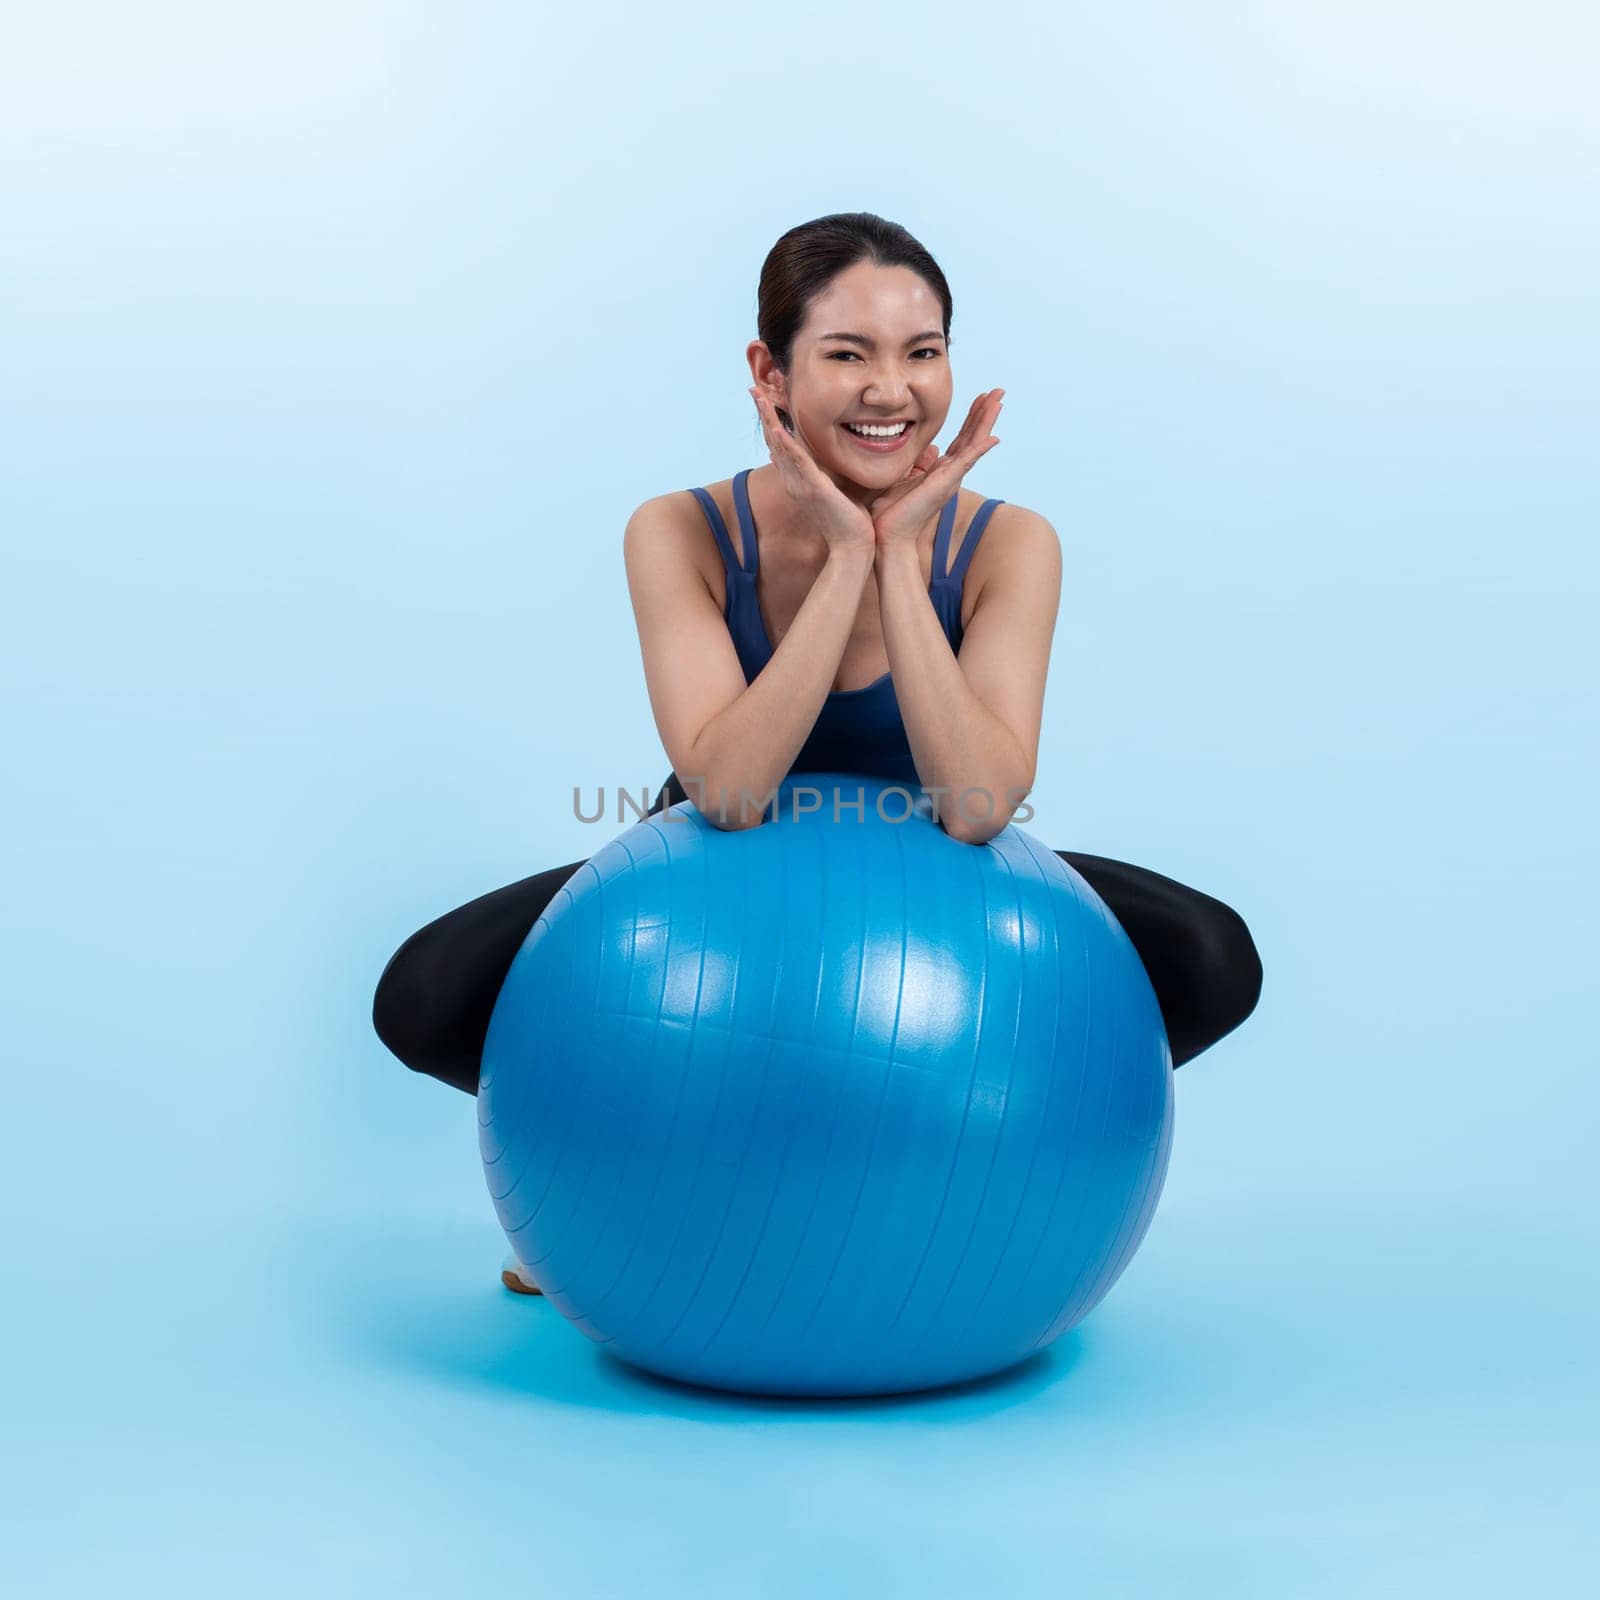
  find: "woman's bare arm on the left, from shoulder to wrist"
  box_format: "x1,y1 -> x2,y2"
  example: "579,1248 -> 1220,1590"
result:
622,493 -> 874,830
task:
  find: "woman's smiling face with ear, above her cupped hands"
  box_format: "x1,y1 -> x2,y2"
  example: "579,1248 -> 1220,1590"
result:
749,261 -> 952,493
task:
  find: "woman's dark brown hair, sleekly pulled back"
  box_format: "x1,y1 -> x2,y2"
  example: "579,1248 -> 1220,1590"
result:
755,211 -> 950,432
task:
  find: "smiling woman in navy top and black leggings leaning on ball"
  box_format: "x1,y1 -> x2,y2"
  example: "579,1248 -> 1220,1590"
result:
373,213 -> 1261,1293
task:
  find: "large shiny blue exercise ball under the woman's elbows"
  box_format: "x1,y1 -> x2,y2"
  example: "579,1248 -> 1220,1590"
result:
478,773 -> 1173,1395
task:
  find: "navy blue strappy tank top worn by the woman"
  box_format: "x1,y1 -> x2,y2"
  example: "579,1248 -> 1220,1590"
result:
691,467 -> 1005,786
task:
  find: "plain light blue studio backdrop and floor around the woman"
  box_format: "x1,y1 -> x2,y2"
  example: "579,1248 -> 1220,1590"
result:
0,0 -> 1600,1600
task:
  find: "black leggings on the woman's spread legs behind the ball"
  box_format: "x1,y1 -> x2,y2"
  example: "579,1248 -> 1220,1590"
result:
373,773 -> 1261,1094
